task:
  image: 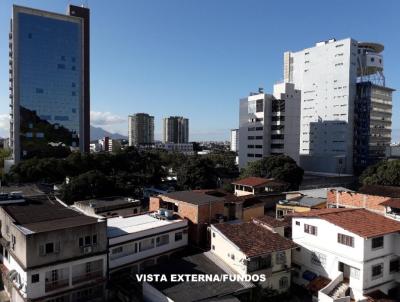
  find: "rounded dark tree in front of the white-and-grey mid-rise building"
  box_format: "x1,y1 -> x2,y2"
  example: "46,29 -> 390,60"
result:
240,155 -> 304,190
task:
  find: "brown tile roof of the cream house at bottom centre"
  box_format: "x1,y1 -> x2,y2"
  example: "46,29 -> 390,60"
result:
213,222 -> 296,257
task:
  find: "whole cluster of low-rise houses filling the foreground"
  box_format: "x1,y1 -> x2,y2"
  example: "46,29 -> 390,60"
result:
0,177 -> 400,302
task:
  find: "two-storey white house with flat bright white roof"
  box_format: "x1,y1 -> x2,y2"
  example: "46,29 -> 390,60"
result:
107,210 -> 188,279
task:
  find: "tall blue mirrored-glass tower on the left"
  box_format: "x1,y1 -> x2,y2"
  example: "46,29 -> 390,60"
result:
9,5 -> 90,162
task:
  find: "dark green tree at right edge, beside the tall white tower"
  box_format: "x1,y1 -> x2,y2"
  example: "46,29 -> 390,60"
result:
359,160 -> 400,186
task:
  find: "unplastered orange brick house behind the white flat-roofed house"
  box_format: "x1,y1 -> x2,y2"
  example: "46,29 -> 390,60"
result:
149,191 -> 225,246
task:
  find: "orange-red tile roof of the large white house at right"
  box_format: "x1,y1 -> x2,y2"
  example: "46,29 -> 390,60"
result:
293,208 -> 400,238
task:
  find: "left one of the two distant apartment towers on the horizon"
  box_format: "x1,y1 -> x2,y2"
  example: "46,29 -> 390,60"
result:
128,113 -> 154,146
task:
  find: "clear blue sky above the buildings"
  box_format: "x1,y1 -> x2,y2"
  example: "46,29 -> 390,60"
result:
0,0 -> 400,141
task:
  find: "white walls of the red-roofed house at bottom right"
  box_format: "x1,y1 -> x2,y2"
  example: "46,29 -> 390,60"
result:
292,218 -> 399,293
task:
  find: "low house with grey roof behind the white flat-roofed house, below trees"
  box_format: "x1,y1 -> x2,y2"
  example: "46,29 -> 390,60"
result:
73,197 -> 141,218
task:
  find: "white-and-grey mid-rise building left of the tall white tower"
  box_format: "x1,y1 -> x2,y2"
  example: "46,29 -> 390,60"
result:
239,83 -> 300,168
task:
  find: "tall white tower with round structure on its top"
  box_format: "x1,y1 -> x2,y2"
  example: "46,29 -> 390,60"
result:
284,38 -> 393,174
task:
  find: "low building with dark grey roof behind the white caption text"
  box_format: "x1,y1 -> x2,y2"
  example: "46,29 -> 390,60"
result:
143,252 -> 255,302
